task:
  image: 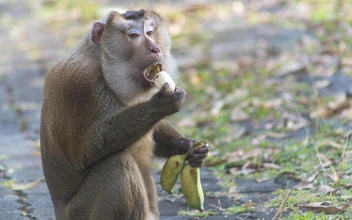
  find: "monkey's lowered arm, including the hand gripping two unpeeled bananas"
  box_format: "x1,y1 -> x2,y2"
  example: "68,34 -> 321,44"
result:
153,119 -> 209,166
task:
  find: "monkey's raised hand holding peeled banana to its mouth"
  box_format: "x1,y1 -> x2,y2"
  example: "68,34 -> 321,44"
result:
150,83 -> 186,116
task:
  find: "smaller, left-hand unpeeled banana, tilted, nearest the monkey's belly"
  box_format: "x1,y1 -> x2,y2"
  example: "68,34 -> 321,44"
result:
160,153 -> 188,195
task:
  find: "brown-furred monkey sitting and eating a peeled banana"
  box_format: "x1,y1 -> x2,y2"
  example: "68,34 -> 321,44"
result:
40,9 -> 209,220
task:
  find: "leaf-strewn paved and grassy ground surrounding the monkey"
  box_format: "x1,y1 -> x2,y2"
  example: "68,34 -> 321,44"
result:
0,0 -> 352,220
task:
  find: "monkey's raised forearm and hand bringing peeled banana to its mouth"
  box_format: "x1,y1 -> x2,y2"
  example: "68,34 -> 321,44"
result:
69,86 -> 185,169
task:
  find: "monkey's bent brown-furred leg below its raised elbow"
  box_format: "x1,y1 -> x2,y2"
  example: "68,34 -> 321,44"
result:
64,152 -> 149,220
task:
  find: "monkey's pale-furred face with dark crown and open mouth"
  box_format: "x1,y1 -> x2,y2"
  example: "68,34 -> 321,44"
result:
92,10 -> 170,89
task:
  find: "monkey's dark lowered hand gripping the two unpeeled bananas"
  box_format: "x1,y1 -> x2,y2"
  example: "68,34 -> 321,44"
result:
177,138 -> 210,167
